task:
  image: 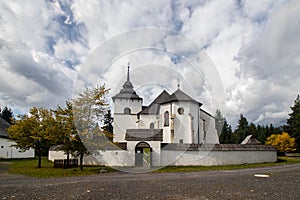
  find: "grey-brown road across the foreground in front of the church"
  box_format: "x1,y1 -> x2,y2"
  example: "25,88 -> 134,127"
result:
0,164 -> 300,199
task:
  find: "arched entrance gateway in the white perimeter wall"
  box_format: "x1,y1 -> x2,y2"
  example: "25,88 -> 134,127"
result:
135,142 -> 152,167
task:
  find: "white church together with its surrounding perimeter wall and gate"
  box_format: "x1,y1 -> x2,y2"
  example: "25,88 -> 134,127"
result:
87,66 -> 277,167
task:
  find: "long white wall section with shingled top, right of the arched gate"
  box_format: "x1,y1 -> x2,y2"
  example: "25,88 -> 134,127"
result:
161,144 -> 277,166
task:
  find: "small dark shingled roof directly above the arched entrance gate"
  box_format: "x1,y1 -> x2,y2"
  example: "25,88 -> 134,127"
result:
125,129 -> 163,141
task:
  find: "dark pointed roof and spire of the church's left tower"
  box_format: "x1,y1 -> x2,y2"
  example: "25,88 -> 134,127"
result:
112,65 -> 142,100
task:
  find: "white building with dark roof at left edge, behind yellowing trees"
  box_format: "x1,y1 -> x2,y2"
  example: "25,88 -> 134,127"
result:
0,117 -> 34,158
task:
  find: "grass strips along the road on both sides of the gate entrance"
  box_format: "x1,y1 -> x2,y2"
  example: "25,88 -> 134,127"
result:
0,157 -> 300,178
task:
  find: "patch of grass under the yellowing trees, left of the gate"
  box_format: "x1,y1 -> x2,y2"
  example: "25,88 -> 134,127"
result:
6,158 -> 115,178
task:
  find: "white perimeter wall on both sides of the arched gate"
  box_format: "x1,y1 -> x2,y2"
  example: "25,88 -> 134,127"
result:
87,146 -> 277,166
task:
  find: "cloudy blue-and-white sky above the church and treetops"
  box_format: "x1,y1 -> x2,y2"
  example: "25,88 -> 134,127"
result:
0,0 -> 300,126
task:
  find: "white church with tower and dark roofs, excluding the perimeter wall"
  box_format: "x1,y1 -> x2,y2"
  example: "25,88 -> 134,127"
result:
112,66 -> 219,146
